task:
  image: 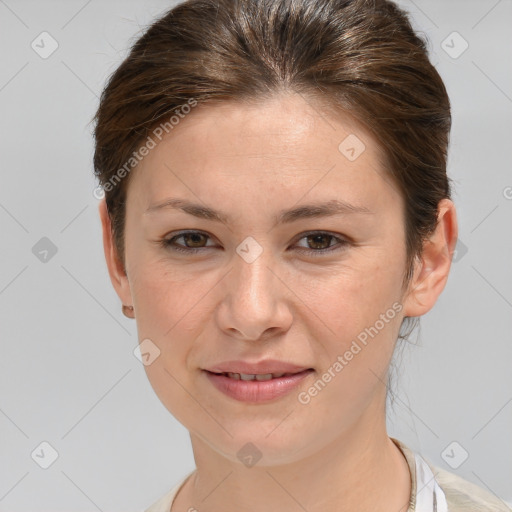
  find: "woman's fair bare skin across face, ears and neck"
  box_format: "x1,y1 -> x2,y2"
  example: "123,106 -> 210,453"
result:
99,93 -> 457,512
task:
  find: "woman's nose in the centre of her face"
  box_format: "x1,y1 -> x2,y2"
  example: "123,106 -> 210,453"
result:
217,249 -> 293,341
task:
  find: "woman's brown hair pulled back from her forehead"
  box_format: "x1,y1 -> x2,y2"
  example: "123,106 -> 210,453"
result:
94,0 -> 451,338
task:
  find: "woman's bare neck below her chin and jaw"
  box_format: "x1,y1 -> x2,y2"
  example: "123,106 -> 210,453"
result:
172,406 -> 411,512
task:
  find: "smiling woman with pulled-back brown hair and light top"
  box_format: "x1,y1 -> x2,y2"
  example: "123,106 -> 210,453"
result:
94,0 -> 509,512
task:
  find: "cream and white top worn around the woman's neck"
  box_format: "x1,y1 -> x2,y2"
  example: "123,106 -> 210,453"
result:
145,438 -> 512,512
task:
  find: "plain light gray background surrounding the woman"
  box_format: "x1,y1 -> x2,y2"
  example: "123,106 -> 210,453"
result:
0,0 -> 512,512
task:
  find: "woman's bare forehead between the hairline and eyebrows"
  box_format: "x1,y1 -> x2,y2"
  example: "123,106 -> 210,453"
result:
129,94 -> 397,208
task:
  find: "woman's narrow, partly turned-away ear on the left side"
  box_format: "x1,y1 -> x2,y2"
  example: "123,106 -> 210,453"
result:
98,199 -> 133,306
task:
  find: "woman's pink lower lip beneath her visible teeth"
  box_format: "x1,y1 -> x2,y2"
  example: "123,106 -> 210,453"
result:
205,370 -> 313,403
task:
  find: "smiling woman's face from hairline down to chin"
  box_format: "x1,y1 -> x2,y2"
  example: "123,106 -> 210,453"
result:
104,91 -> 432,465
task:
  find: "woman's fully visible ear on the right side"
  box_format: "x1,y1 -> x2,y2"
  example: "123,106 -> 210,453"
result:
403,199 -> 458,317
